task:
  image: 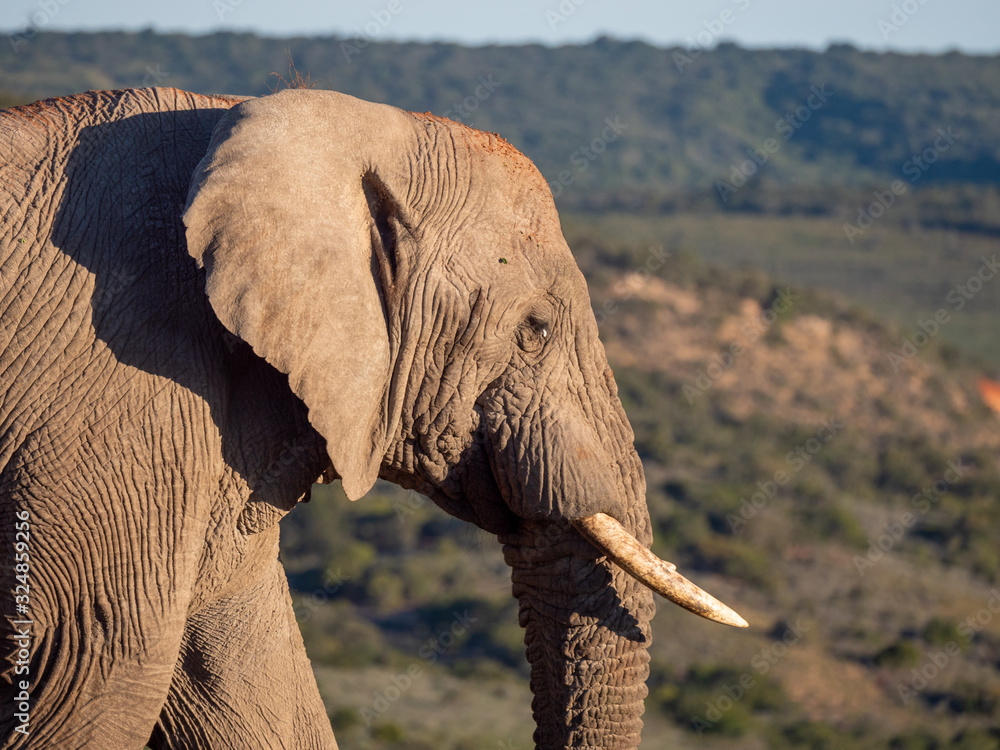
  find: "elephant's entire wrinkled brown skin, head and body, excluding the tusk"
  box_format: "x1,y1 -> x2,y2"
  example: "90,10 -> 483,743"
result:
0,89 -> 653,749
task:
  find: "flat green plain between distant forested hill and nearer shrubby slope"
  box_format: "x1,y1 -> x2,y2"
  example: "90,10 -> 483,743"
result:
562,210 -> 1000,374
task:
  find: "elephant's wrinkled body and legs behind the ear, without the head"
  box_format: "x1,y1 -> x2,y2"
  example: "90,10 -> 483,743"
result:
0,89 -> 335,748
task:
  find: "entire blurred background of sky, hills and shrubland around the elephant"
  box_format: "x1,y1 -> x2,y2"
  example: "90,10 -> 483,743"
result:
0,0 -> 1000,750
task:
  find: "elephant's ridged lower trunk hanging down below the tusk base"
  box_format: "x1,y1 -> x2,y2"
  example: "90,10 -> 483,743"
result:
501,522 -> 653,750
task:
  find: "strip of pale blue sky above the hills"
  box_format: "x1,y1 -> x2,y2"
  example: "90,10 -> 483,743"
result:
0,0 -> 1000,54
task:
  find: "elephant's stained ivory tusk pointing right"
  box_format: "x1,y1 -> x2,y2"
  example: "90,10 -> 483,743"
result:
570,513 -> 748,628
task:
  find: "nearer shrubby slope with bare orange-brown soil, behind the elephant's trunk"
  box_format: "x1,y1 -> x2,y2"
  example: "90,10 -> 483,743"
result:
284,241 -> 1000,748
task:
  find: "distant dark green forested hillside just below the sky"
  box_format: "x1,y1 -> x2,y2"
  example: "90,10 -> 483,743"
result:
0,32 -> 1000,199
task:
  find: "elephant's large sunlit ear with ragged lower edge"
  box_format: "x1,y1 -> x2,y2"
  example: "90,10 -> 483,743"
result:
184,90 -> 410,500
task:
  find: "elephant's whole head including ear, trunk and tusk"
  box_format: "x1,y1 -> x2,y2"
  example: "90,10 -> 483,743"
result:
184,90 -> 745,748
